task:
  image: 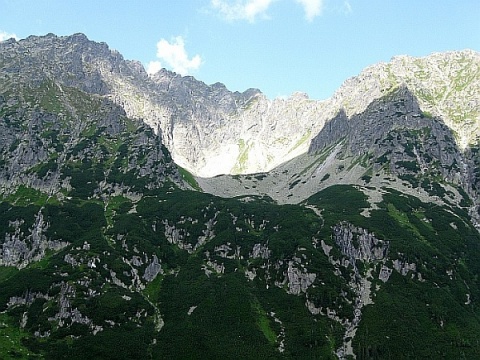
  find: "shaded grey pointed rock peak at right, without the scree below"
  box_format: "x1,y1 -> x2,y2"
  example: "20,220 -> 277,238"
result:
309,87 -> 470,187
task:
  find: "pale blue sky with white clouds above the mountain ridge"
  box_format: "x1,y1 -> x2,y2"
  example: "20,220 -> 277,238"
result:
0,0 -> 480,100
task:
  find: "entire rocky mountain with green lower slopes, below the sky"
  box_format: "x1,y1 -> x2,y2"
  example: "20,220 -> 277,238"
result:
0,34 -> 480,359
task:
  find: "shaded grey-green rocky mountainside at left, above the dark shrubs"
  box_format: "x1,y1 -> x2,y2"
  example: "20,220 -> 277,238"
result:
0,35 -> 186,196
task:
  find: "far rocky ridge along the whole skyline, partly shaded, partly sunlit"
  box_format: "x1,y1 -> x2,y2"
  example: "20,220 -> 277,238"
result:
0,34 -> 480,177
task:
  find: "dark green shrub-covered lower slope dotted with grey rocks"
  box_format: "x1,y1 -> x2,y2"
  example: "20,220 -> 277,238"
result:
0,186 -> 480,359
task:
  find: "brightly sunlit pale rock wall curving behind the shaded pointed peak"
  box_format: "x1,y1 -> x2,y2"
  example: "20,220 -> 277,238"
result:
147,50 -> 480,176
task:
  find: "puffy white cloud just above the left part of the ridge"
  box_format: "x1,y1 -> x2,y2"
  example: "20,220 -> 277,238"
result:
147,36 -> 202,76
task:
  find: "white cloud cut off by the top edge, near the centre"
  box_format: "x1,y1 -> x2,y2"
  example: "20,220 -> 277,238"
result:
211,0 -> 276,23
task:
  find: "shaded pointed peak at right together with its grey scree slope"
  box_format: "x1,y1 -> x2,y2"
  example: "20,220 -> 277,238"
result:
199,86 -> 480,225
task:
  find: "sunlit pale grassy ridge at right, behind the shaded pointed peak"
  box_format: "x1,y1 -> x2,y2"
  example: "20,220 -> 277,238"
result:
333,49 -> 480,149
